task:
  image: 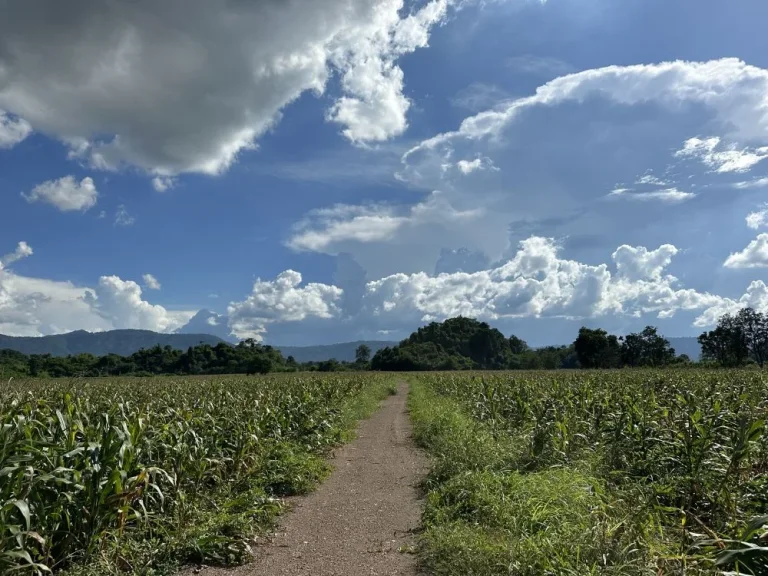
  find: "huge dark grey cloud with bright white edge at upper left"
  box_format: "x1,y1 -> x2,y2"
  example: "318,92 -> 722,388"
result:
0,0 -> 453,177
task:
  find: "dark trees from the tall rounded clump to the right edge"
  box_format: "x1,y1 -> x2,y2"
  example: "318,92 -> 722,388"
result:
371,308 -> 768,371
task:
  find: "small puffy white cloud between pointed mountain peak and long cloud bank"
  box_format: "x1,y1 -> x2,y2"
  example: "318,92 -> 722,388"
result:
227,270 -> 343,340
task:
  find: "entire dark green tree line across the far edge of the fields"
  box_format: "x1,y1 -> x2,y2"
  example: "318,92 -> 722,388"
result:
0,308 -> 768,378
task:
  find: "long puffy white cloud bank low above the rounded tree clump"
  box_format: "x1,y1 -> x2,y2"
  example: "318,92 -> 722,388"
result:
364,237 -> 737,325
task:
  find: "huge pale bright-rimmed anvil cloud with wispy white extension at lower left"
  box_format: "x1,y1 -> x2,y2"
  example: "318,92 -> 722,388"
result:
298,58 -> 768,277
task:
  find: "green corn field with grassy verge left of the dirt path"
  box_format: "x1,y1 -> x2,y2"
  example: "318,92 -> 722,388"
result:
0,374 -> 383,574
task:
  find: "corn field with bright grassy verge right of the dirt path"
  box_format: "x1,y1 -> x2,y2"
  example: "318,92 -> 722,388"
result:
410,369 -> 768,576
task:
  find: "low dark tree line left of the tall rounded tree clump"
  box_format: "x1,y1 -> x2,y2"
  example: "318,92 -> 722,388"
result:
0,340 -> 370,379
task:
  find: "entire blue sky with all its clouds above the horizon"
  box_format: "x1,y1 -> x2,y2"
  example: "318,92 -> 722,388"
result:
0,0 -> 768,345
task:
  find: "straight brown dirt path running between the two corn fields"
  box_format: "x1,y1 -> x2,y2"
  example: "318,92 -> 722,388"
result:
195,383 -> 426,576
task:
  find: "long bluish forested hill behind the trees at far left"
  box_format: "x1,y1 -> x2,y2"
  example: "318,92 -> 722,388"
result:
0,330 -> 223,356
